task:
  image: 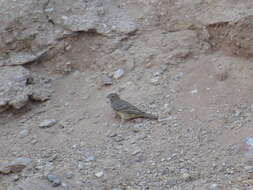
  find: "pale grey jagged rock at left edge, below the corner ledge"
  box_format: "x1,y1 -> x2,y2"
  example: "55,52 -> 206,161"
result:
0,66 -> 52,112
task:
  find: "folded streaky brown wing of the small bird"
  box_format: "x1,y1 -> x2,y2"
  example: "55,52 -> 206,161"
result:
112,100 -> 145,115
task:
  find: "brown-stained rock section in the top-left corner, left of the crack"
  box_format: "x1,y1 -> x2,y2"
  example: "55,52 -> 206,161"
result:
0,0 -> 63,66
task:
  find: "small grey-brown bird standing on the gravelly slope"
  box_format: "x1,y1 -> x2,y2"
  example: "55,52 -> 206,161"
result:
107,93 -> 158,124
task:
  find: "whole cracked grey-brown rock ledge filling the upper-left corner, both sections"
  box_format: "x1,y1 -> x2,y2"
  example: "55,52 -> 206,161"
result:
0,0 -> 136,66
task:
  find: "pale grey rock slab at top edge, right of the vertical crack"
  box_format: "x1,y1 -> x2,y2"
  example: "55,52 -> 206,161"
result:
44,0 -> 137,36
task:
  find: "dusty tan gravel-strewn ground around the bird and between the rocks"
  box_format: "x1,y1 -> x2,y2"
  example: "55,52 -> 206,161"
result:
0,0 -> 253,190
